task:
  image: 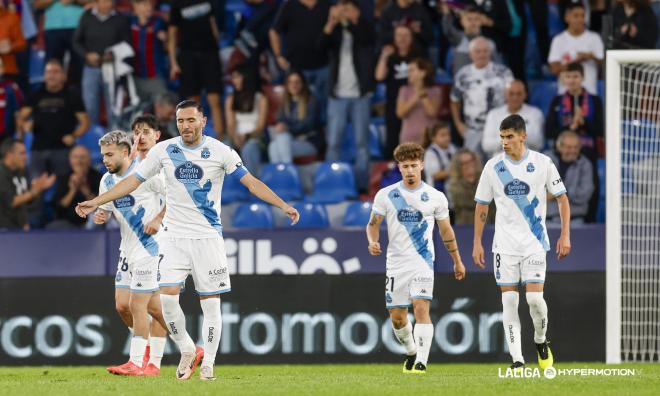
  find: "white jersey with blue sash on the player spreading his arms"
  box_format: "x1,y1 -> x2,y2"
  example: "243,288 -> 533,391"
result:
135,136 -> 247,238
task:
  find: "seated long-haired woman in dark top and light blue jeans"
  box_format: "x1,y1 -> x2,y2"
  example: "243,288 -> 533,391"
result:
268,71 -> 322,163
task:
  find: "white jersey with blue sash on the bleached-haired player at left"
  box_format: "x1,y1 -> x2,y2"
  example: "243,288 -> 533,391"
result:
99,161 -> 165,260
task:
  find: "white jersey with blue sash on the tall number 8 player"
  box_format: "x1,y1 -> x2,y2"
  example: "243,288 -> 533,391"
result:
474,149 -> 566,256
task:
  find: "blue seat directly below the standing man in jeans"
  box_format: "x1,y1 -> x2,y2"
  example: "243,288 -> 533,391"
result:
309,162 -> 357,204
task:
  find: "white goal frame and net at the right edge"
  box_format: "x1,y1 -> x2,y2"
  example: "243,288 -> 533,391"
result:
606,51 -> 660,363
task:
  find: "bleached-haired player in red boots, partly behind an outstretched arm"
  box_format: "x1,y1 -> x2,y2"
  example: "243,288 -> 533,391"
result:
94,131 -> 167,376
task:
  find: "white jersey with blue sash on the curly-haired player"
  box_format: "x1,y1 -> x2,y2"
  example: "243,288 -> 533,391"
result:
372,182 -> 449,272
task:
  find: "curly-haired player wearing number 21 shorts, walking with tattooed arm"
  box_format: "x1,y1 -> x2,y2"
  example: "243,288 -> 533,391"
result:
367,143 -> 465,374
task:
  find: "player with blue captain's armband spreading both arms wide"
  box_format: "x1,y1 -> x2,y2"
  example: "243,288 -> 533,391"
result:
76,100 -> 299,380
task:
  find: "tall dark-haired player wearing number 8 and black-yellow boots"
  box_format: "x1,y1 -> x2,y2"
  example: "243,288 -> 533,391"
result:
472,114 -> 571,369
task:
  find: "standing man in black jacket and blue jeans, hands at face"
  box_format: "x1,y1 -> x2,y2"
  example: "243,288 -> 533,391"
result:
322,0 -> 375,189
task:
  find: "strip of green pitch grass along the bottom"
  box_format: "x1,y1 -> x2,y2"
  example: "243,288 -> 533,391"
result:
0,363 -> 660,396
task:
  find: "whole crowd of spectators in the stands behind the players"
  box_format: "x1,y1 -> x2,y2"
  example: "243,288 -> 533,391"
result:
0,0 -> 660,230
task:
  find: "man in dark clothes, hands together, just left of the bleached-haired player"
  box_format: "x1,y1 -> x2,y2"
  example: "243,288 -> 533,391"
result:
47,146 -> 101,228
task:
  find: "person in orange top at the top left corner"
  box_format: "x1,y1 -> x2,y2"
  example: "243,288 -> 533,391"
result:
0,1 -> 27,81
